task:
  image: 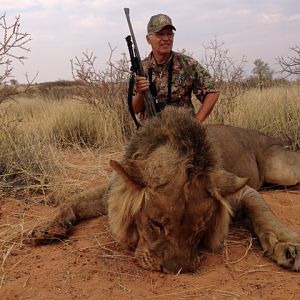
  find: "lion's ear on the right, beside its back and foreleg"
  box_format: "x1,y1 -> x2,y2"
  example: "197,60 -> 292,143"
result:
208,170 -> 248,197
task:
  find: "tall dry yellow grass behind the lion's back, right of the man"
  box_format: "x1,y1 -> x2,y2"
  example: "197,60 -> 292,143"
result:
209,85 -> 300,149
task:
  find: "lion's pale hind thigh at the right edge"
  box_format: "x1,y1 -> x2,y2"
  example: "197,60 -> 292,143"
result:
263,145 -> 300,186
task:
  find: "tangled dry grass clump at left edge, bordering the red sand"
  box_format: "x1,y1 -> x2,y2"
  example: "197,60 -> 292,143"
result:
0,124 -> 64,193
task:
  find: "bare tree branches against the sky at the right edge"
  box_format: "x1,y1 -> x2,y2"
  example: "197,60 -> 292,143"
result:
277,45 -> 300,77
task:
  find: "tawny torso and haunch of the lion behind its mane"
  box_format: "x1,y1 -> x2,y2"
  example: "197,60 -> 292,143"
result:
207,125 -> 300,189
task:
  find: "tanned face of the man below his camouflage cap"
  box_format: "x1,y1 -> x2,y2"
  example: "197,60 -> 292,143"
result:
147,27 -> 174,56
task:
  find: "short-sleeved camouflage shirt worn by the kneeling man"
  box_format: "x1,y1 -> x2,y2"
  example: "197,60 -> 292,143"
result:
143,52 -> 217,107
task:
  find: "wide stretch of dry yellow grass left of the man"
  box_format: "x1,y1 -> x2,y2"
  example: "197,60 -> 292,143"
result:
0,93 -> 132,193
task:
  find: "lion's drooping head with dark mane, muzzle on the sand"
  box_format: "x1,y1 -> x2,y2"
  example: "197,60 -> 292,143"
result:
108,108 -> 246,273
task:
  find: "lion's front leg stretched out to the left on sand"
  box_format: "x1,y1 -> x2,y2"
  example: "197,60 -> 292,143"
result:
29,185 -> 107,244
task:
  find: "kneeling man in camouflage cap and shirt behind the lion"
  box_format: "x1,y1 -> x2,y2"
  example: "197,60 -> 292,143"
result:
132,14 -> 219,123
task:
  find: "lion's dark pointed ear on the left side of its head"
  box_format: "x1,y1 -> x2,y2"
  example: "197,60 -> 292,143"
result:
109,160 -> 145,189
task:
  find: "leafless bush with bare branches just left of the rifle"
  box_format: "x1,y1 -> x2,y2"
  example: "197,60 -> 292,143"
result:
71,44 -> 132,136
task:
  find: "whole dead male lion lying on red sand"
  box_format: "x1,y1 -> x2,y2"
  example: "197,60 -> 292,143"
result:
31,107 -> 300,274
